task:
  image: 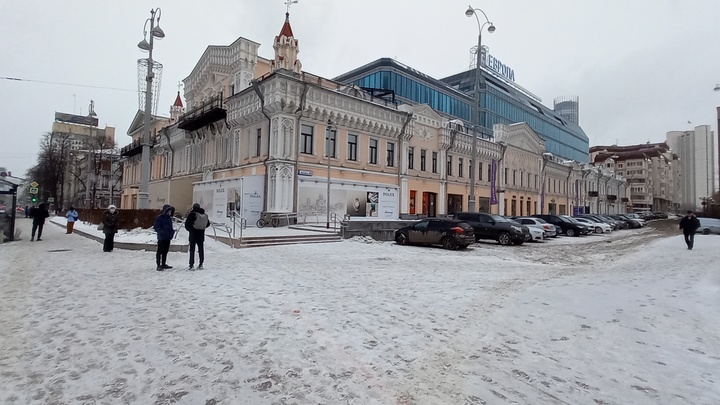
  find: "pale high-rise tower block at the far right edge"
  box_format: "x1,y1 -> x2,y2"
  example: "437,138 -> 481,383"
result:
667,125 -> 717,210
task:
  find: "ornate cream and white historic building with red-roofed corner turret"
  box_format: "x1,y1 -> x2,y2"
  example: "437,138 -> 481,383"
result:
123,11 -> 624,224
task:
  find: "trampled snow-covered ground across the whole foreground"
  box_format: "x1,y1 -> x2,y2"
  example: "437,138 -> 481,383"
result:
0,219 -> 720,405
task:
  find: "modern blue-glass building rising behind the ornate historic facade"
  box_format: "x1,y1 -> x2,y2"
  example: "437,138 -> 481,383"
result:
334,58 -> 590,163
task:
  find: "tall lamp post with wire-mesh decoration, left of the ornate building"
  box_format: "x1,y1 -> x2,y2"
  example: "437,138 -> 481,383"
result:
138,8 -> 165,209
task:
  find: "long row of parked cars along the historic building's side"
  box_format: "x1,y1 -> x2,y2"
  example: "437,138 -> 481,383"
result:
395,212 -> 646,249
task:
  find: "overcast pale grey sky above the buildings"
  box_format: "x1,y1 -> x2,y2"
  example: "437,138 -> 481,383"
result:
0,0 -> 720,175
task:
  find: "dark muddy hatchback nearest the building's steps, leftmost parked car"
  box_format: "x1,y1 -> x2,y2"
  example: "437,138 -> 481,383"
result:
395,218 -> 475,249
